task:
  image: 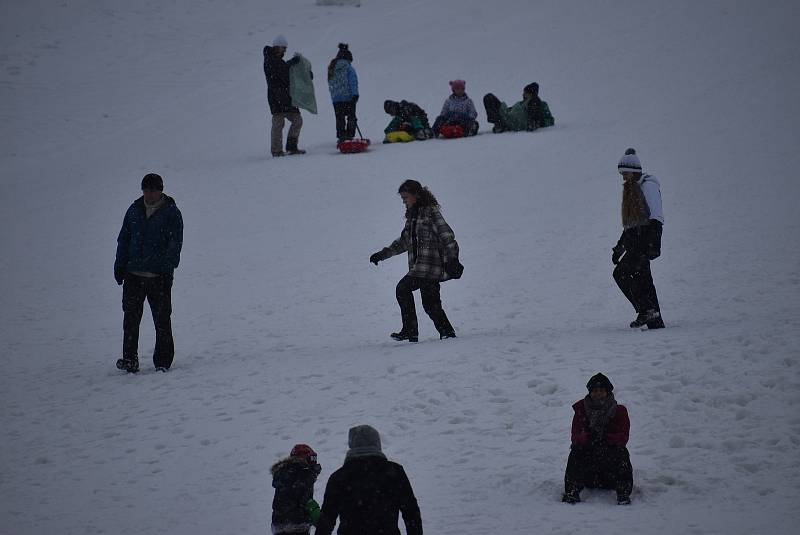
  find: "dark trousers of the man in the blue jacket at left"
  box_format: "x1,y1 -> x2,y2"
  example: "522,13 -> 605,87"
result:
122,273 -> 175,368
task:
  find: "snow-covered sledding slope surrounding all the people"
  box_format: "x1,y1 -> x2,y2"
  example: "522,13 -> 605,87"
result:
0,0 -> 800,535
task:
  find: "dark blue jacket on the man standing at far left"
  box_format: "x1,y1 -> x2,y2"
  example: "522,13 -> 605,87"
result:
114,195 -> 183,275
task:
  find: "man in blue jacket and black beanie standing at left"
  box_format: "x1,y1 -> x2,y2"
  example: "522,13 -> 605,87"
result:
114,173 -> 183,373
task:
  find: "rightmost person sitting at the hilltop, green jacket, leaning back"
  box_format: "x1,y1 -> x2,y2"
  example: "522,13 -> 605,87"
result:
483,82 -> 555,134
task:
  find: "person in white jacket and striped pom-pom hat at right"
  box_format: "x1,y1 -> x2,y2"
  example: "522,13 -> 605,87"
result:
611,149 -> 664,329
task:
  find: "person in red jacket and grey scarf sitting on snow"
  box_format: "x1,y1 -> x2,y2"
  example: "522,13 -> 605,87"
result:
561,373 -> 633,505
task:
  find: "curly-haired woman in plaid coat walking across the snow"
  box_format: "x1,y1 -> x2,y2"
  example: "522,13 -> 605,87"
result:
369,180 -> 464,342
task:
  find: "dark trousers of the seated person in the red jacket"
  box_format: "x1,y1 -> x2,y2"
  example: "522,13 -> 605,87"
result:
564,445 -> 633,496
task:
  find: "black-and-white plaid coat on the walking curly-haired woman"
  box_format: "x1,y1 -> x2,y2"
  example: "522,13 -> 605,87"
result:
383,206 -> 458,281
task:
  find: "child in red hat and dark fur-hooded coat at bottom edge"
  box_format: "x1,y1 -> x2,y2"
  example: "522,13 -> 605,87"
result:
272,444 -> 322,535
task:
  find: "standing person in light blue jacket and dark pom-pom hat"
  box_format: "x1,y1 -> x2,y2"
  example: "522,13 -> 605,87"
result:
328,43 -> 358,143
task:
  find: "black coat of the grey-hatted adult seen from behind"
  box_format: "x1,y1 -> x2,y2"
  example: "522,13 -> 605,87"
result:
316,456 -> 422,535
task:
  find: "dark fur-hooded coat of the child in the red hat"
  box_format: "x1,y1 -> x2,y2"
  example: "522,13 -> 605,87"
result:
272,457 -> 319,533
